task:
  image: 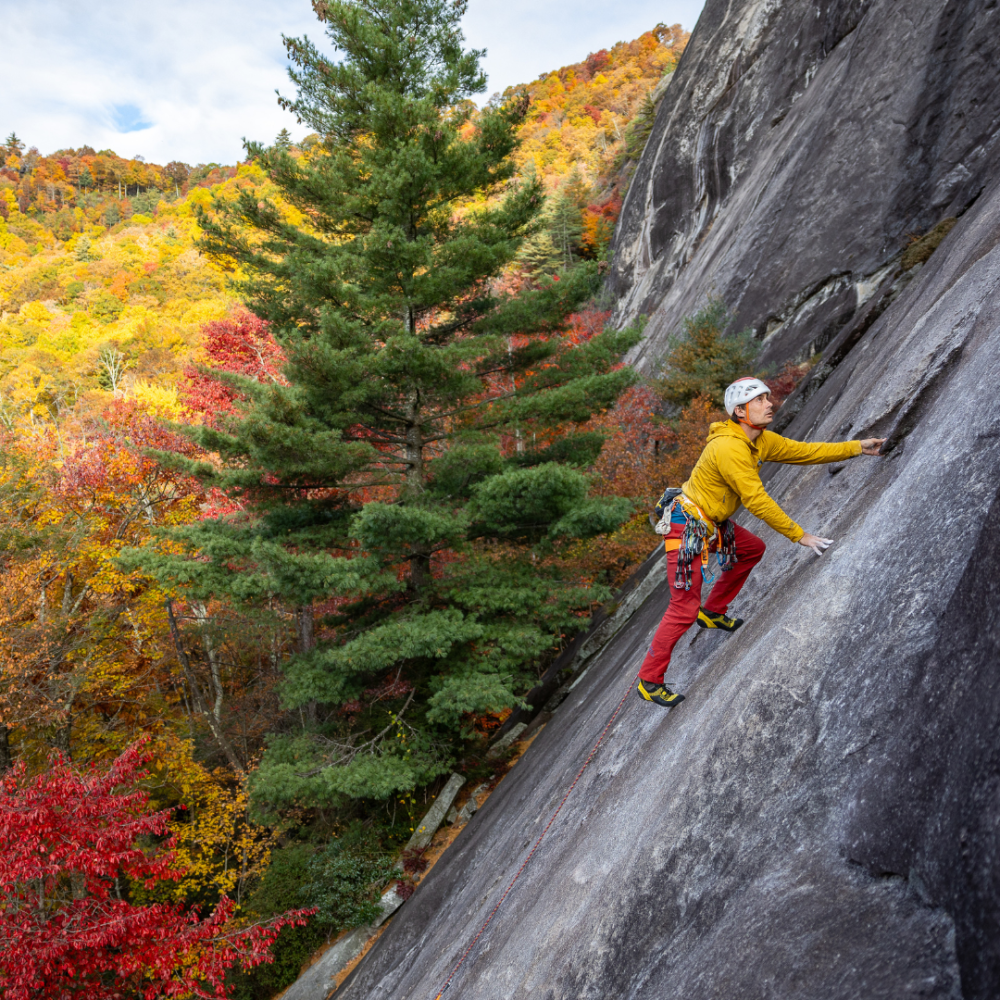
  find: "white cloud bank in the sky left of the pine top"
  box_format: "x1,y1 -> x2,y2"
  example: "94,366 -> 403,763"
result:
0,0 -> 321,163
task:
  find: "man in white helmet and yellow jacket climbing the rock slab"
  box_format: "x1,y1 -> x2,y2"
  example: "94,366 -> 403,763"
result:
638,378 -> 885,708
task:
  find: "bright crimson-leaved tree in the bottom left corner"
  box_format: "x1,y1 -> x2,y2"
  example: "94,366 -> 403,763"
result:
0,743 -> 314,1000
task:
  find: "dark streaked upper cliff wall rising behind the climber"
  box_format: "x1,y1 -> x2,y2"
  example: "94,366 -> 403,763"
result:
612,0 -> 1000,369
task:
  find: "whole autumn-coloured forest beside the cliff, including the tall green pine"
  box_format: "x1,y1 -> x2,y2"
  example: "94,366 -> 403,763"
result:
0,0 -> 801,1000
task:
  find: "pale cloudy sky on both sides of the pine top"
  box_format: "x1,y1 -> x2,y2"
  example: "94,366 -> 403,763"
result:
0,0 -> 703,164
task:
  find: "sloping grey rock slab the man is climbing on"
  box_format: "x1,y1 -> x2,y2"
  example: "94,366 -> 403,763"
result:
330,152 -> 1000,1000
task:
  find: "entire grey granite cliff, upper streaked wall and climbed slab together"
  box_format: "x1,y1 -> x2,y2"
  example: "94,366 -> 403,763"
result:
328,0 -> 1000,1000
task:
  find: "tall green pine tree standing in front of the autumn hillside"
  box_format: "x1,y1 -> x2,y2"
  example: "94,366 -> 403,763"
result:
132,0 -> 637,808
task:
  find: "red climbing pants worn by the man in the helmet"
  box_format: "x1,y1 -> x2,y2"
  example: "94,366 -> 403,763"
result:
639,524 -> 764,684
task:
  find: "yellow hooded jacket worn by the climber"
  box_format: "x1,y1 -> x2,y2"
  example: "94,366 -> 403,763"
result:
681,420 -> 861,542
